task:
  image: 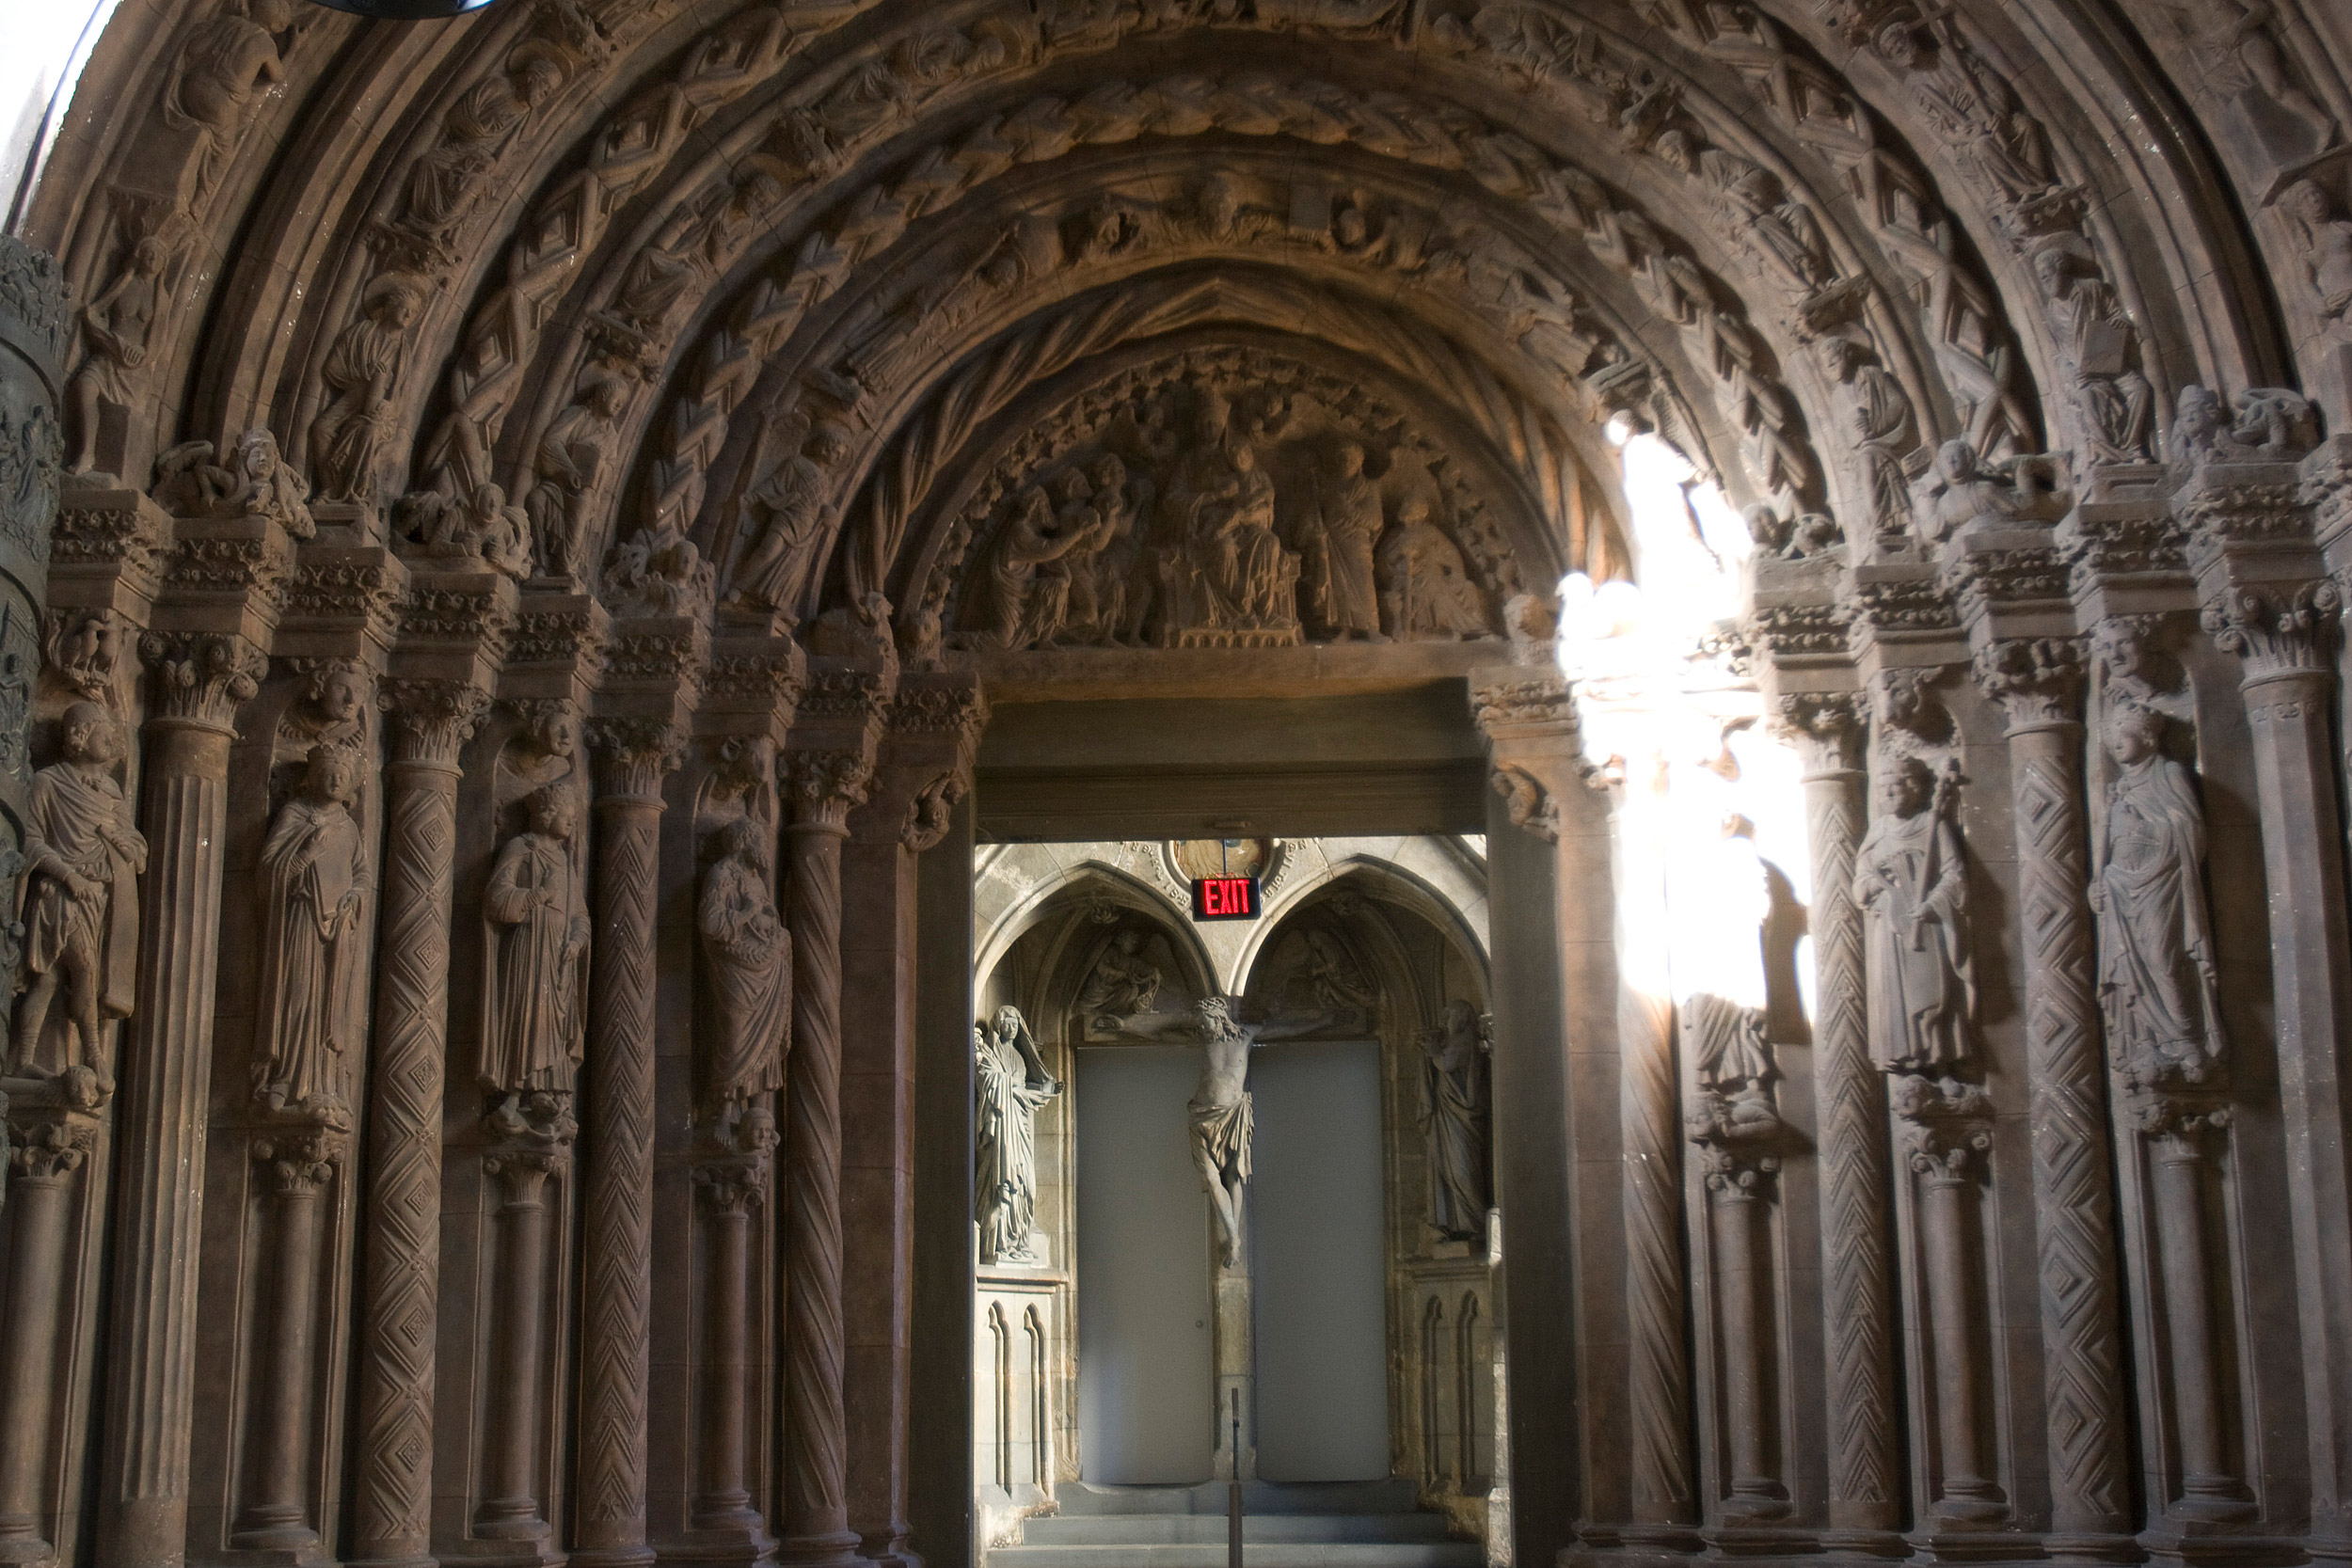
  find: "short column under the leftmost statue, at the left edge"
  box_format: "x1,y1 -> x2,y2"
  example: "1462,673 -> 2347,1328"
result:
0,1119 -> 97,1563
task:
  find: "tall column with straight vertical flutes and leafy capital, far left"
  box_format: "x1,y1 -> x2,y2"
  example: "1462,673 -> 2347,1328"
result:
99,635 -> 262,1568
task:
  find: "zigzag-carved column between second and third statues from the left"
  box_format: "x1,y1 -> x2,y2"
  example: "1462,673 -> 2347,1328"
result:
353,684 -> 483,1568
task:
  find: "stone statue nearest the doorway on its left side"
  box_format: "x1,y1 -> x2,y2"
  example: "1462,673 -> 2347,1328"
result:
694,816 -> 793,1148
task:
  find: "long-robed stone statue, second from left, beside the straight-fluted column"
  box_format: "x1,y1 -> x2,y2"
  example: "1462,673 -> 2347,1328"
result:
254,743 -> 374,1124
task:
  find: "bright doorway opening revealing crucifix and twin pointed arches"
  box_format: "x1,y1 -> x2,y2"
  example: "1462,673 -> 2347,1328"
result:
972,834 -> 1505,1568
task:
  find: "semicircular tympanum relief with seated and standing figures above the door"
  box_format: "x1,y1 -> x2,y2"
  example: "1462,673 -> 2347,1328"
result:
931,350 -> 1518,651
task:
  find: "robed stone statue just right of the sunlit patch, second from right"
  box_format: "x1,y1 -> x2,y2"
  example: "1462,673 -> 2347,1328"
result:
1853,757 -> 1976,1077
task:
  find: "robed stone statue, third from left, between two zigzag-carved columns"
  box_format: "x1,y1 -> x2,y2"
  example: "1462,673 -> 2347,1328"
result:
483,787 -> 588,1119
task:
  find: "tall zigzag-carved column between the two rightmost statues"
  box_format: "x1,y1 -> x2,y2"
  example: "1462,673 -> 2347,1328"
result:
1983,667 -> 2131,1559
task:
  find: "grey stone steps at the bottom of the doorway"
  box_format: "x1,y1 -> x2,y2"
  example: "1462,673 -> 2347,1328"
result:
988,1481 -> 1486,1568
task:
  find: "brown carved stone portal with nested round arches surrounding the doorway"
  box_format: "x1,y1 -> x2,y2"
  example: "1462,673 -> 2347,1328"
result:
0,0 -> 2352,1566
